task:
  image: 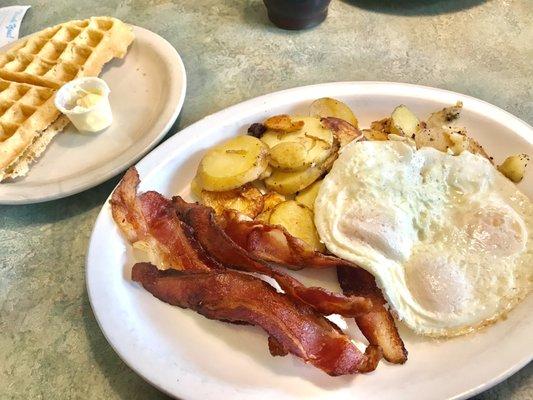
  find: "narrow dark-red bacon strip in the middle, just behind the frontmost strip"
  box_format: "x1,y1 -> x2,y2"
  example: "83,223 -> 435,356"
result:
172,197 -> 372,317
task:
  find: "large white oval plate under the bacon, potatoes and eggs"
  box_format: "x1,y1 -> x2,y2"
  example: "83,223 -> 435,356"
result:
87,82 -> 533,400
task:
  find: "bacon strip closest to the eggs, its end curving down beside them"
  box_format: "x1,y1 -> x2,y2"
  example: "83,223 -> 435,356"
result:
223,210 -> 407,364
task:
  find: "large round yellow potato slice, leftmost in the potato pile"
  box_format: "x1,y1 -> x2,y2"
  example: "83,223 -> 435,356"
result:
196,135 -> 268,192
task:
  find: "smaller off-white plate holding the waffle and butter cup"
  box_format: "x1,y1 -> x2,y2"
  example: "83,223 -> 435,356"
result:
0,26 -> 186,204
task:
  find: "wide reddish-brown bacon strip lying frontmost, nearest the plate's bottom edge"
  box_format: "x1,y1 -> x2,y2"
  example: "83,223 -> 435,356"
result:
132,263 -> 381,376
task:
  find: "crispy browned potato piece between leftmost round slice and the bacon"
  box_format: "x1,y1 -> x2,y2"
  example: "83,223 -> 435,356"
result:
200,184 -> 264,218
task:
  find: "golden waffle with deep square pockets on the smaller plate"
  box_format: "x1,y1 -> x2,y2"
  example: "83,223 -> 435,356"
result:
0,17 -> 134,181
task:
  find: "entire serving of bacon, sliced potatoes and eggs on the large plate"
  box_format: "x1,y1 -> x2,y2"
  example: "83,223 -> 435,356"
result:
111,98 -> 533,376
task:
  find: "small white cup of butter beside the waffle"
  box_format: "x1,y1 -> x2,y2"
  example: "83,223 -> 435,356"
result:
55,78 -> 113,132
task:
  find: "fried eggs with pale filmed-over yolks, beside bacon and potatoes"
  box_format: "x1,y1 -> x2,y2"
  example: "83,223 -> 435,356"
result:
315,141 -> 533,336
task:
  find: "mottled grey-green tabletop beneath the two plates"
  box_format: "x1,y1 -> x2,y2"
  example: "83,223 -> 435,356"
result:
0,0 -> 533,400
